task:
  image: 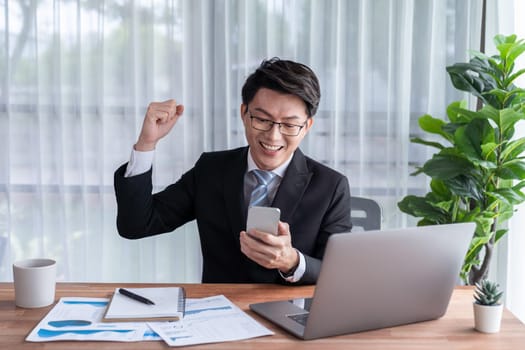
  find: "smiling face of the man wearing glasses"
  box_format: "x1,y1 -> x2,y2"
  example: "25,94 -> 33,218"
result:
241,88 -> 313,170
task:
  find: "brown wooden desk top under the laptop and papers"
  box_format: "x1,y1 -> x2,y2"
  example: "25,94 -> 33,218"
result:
0,283 -> 525,350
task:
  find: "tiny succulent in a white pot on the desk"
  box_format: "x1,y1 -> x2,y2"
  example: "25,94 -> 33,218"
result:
474,279 -> 503,333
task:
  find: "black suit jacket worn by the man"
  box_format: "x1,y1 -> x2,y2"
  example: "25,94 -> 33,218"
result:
114,147 -> 352,284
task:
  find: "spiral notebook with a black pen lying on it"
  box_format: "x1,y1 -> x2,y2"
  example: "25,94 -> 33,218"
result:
102,287 -> 186,322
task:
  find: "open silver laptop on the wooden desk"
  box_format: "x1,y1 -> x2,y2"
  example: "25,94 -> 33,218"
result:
250,223 -> 475,339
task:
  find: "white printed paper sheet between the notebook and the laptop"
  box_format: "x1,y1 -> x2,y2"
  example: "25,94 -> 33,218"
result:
148,295 -> 273,346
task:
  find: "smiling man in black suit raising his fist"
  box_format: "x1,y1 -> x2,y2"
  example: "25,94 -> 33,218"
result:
115,58 -> 352,284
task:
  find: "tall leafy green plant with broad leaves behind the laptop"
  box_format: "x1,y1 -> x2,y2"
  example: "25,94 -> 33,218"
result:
398,35 -> 525,285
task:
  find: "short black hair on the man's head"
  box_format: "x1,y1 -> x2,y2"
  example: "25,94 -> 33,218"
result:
242,57 -> 321,117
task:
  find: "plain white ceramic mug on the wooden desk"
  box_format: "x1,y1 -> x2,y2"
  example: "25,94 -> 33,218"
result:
13,259 -> 56,308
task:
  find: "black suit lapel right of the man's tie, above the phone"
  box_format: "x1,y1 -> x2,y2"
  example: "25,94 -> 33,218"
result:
272,149 -> 312,222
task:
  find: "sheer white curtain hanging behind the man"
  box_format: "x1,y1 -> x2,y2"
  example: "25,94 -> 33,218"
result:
0,0 -> 506,282
